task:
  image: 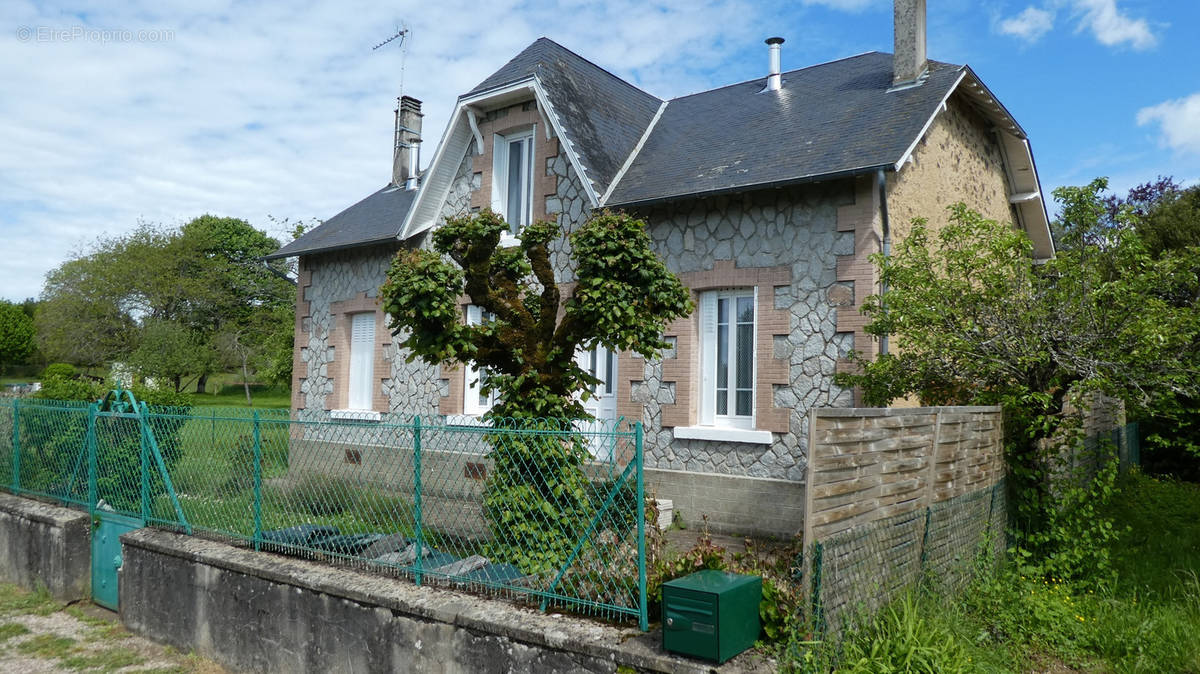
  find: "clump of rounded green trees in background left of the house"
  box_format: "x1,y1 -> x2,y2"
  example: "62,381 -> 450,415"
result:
35,215 -> 295,389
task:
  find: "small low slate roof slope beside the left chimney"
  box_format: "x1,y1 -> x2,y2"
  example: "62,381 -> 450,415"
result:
265,183 -> 416,260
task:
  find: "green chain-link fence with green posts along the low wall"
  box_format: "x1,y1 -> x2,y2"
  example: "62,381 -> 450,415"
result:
0,393 -> 648,630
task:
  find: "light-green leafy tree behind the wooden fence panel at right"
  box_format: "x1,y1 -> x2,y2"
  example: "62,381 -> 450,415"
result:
841,180 -> 1200,573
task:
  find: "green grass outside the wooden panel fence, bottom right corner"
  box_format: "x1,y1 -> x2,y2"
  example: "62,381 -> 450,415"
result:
787,474 -> 1200,673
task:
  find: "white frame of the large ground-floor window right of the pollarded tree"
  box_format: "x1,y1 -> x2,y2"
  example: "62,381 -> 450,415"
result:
700,288 -> 758,429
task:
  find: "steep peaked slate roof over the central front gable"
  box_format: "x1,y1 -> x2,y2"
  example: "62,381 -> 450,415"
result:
462,37 -> 662,194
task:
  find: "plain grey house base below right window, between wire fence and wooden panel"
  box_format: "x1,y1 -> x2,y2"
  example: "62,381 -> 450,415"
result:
646,468 -> 804,538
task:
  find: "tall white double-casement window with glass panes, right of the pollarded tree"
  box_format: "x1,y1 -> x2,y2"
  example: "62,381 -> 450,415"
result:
700,288 -> 756,428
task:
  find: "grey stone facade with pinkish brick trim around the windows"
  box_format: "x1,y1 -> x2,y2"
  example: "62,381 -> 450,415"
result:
294,85 -> 1013,494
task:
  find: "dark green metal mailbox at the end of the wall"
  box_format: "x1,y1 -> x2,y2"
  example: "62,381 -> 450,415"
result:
662,571 -> 762,663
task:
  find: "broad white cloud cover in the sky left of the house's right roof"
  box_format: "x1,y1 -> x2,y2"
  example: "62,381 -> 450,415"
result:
0,0 -> 758,299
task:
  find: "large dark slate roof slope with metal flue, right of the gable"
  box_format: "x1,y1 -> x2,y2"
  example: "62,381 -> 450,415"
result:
606,52 -> 964,205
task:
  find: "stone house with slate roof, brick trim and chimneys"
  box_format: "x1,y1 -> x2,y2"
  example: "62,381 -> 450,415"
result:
267,0 -> 1054,535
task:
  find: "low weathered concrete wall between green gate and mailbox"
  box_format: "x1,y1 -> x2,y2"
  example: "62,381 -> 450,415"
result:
120,529 -> 766,673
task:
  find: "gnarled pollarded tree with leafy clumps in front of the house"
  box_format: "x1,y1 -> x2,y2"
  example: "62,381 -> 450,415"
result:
380,210 -> 691,572
